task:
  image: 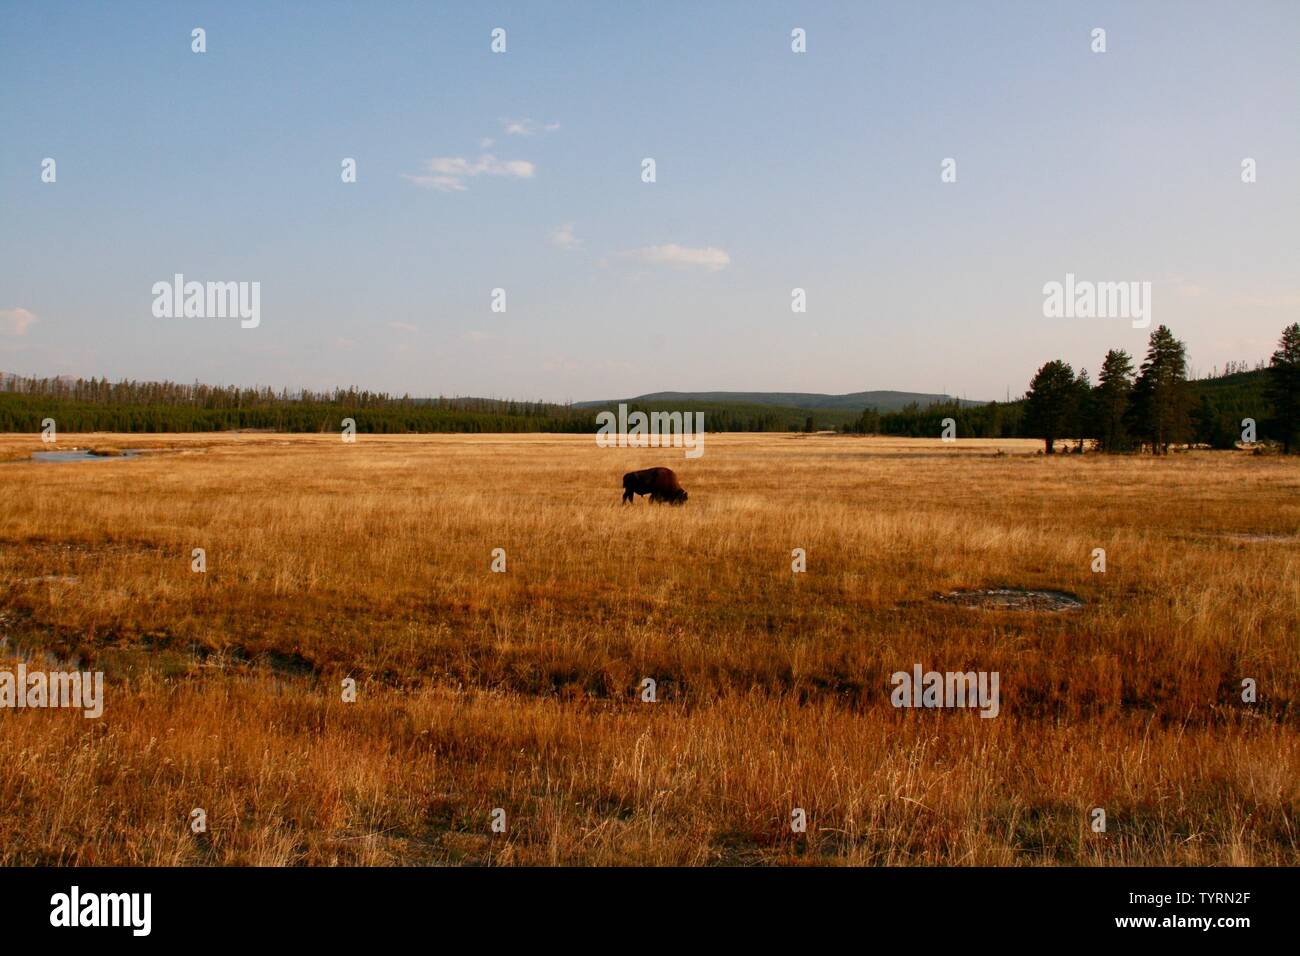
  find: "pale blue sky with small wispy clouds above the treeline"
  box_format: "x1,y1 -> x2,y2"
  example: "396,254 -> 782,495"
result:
0,0 -> 1300,402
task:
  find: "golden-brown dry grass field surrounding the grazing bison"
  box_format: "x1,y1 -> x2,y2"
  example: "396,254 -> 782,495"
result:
0,434 -> 1300,865
